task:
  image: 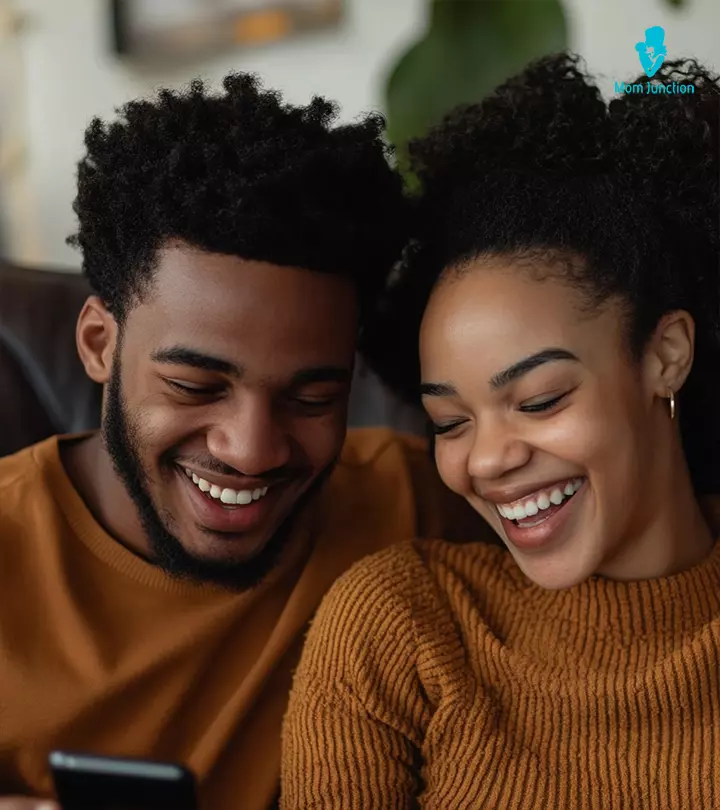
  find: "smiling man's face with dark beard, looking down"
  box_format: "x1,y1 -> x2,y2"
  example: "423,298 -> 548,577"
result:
95,240 -> 357,589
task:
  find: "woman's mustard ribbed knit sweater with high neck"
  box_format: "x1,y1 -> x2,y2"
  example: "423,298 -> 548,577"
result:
281,541 -> 720,810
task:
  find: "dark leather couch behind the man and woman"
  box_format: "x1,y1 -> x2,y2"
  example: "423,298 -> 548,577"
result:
0,262 -> 424,456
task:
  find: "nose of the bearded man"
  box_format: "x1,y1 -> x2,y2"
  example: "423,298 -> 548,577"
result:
207,399 -> 292,476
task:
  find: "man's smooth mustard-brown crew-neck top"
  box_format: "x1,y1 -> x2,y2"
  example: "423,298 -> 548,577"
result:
0,428 -> 490,810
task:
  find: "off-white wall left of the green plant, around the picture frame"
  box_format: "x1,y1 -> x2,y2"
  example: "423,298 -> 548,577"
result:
11,0 -> 425,266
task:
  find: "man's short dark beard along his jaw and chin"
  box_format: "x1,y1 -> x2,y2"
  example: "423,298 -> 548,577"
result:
102,355 -> 337,591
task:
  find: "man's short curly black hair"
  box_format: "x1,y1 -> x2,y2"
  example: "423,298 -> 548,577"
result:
68,73 -> 408,324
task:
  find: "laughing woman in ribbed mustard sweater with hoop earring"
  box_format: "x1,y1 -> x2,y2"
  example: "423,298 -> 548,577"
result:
283,56 -> 720,810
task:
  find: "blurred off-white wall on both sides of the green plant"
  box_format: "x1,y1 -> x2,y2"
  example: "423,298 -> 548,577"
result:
5,0 -> 720,267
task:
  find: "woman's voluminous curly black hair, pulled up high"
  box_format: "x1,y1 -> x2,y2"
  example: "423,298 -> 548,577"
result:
362,54 -> 720,492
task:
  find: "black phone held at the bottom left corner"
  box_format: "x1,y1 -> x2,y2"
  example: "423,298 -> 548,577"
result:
50,751 -> 198,810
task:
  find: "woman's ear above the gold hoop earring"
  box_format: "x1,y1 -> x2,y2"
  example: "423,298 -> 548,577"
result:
645,310 -> 695,398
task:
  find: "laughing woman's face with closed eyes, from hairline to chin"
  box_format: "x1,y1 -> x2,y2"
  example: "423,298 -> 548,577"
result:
420,258 -> 672,588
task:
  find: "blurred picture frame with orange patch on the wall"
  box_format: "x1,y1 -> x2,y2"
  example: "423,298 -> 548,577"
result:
109,0 -> 343,62
